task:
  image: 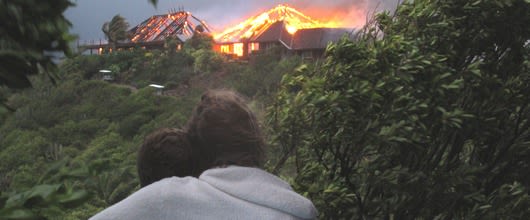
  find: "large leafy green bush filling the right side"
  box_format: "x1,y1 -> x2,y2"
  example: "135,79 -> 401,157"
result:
270,0 -> 530,219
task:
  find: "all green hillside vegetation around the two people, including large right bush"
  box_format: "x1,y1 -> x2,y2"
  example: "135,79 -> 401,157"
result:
0,0 -> 530,219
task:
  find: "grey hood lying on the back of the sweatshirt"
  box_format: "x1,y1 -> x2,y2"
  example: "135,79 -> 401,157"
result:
199,166 -> 317,219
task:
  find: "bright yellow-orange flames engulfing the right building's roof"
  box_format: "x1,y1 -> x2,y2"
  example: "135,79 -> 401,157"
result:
214,4 -> 341,42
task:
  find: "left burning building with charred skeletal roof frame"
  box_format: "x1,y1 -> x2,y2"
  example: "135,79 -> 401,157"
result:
84,11 -> 210,53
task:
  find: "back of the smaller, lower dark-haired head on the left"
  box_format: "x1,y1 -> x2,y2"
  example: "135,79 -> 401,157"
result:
137,128 -> 193,187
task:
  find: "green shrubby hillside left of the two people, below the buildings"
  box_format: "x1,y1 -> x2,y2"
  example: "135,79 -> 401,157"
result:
0,34 -> 299,219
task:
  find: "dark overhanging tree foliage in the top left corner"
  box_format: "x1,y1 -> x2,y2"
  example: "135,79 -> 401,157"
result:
0,0 -> 73,110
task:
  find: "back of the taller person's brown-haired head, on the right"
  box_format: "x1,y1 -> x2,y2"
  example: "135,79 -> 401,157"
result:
188,90 -> 264,174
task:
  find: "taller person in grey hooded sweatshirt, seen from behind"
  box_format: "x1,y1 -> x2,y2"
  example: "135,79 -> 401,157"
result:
92,90 -> 317,219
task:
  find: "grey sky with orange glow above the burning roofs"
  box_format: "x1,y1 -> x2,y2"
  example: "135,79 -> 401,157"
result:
65,0 -> 398,41
